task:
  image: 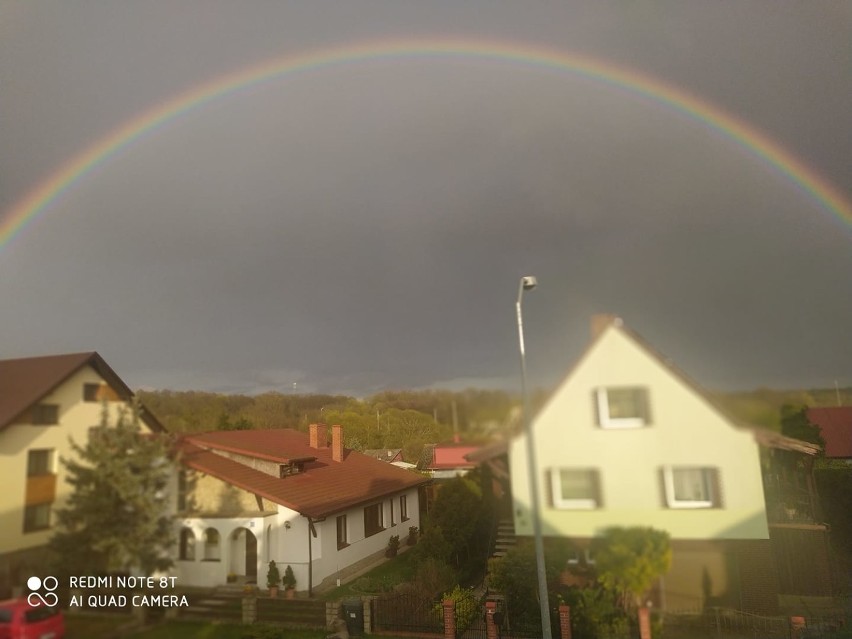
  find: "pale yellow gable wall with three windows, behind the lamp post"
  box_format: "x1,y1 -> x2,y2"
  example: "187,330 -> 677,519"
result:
510,327 -> 769,539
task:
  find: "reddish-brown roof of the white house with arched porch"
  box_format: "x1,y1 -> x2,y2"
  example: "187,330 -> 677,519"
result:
181,428 -> 429,519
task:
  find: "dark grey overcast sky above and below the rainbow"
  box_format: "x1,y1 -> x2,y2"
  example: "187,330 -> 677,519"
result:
0,0 -> 852,395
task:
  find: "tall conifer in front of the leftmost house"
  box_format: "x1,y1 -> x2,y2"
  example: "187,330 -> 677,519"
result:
50,405 -> 174,574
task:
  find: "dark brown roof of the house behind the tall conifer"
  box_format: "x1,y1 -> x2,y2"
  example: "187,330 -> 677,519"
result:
0,352 -> 165,431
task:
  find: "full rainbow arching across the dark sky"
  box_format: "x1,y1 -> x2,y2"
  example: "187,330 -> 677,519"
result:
0,39 -> 852,249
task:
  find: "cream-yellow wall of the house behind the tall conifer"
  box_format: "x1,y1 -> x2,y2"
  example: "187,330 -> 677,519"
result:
0,366 -> 155,554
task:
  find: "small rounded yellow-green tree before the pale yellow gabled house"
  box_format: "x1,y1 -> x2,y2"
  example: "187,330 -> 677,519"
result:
593,526 -> 672,608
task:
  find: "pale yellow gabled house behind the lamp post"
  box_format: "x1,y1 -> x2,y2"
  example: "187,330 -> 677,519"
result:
508,317 -> 824,611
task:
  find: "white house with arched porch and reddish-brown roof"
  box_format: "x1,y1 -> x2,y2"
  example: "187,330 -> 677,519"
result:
174,424 -> 428,592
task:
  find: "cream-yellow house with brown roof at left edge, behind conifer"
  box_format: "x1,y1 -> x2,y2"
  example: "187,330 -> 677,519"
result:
0,352 -> 163,599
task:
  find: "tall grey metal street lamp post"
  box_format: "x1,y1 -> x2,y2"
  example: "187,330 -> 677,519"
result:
515,275 -> 552,639
